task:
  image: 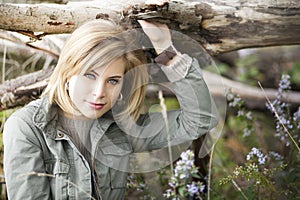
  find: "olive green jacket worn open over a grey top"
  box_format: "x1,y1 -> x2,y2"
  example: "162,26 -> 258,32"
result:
3,55 -> 218,200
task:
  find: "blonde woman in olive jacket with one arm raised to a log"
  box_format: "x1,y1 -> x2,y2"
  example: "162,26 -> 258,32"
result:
4,20 -> 217,200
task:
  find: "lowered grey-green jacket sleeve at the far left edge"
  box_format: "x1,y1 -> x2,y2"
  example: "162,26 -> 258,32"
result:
3,114 -> 51,200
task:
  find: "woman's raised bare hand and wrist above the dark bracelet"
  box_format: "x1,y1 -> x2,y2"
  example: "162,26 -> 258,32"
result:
138,20 -> 172,54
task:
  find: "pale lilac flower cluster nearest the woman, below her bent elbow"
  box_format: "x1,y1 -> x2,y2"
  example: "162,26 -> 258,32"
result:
164,150 -> 205,200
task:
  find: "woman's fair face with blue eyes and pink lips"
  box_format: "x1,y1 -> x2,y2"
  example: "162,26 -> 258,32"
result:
68,59 -> 125,119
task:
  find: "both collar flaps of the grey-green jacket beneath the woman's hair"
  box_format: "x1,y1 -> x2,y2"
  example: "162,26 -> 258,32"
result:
31,96 -> 114,139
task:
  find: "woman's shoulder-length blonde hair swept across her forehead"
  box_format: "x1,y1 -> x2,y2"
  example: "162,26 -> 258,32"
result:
43,19 -> 148,120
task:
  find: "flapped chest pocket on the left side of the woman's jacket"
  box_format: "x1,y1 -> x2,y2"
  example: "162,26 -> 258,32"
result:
45,160 -> 70,200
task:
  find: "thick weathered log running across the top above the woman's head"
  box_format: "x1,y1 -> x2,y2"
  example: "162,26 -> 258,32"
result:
0,0 -> 300,55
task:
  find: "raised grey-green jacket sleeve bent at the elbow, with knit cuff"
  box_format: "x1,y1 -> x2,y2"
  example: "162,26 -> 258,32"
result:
130,54 -> 218,152
